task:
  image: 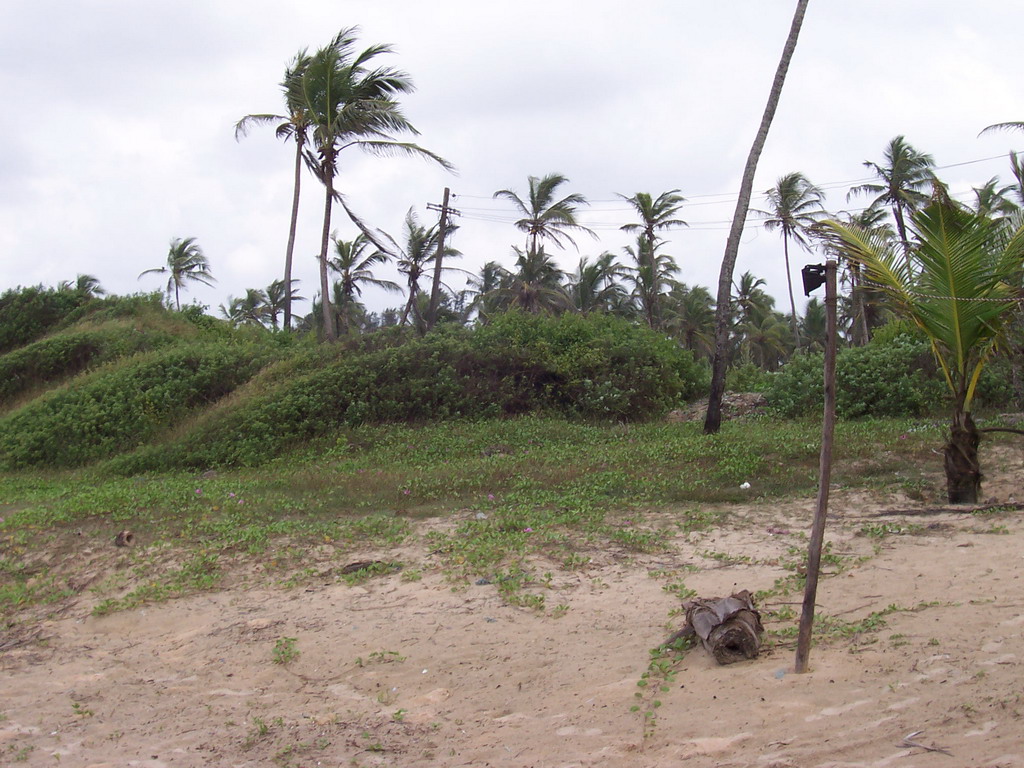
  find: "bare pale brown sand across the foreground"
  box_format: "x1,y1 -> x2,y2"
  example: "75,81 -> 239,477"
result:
0,448 -> 1024,768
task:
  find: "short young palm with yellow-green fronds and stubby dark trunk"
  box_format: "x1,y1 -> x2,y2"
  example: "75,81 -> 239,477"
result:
826,192 -> 1024,503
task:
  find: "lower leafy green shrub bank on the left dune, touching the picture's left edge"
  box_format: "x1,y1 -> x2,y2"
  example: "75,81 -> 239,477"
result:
0,343 -> 266,469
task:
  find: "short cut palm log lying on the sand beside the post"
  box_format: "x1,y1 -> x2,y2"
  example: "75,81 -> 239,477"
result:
666,590 -> 764,664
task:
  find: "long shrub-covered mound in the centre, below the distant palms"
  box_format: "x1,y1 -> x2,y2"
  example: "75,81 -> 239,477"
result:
112,313 -> 702,473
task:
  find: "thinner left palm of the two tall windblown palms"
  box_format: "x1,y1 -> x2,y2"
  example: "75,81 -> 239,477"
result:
234,48 -> 311,330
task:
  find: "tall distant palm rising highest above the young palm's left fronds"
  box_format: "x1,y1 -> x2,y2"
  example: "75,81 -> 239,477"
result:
847,136 -> 935,263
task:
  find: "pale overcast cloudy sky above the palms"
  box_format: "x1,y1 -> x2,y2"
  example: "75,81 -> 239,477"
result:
0,0 -> 1024,313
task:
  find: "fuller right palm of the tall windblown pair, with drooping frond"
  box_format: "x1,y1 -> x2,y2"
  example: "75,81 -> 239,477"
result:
300,27 -> 452,341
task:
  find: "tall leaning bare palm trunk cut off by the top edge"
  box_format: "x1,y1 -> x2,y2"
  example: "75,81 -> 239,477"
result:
703,0 -> 809,434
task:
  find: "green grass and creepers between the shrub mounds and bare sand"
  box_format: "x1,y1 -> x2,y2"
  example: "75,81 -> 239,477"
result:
0,417 -> 954,615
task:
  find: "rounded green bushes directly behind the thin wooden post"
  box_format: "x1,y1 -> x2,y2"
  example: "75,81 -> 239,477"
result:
765,335 -> 946,419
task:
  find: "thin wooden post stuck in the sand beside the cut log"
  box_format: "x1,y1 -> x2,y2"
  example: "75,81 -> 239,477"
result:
797,258 -> 838,673
